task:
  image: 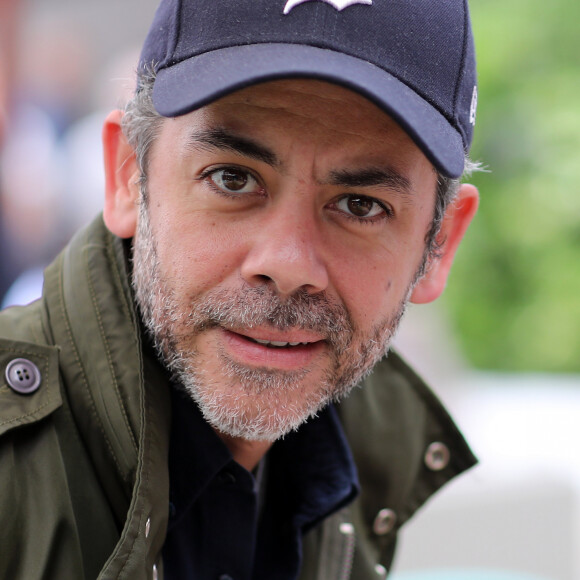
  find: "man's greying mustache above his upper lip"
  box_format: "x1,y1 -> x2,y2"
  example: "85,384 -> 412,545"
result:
185,286 -> 355,352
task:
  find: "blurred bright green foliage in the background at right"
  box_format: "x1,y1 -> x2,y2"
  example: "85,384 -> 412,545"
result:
444,0 -> 580,372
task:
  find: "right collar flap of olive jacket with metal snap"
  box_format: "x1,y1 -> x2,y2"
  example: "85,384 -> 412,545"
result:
338,351 -> 477,541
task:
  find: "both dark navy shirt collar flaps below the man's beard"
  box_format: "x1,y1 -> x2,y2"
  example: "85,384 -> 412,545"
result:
169,385 -> 359,533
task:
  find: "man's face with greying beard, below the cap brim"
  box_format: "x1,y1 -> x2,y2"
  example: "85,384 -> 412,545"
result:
134,80 -> 436,440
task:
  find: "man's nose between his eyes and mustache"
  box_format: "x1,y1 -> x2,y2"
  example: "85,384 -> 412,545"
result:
241,204 -> 328,296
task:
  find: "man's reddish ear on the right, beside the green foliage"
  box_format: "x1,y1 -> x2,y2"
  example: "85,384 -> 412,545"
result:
411,184 -> 479,304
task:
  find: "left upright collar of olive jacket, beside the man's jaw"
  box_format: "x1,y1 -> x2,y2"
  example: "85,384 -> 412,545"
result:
44,218 -> 170,578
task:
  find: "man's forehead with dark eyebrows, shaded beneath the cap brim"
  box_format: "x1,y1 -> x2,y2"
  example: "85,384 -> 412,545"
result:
156,79 -> 435,193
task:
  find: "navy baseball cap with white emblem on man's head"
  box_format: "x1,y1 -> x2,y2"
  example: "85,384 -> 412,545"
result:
139,0 -> 477,178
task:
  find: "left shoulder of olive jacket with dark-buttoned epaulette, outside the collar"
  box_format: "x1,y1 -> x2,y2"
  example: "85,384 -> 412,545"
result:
0,284 -> 119,580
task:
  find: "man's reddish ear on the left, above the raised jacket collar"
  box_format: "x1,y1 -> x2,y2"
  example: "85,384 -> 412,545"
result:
103,111 -> 141,238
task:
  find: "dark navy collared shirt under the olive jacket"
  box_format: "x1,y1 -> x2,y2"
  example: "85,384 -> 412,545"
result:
163,388 -> 358,580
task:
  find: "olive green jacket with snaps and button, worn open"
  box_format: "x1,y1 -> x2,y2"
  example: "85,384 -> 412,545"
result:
0,219 -> 475,580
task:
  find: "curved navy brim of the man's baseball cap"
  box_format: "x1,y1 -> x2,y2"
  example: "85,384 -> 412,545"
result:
153,44 -> 465,178
